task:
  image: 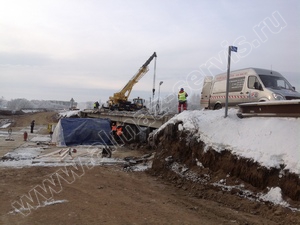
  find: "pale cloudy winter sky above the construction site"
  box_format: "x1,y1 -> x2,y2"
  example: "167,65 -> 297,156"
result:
0,0 -> 300,102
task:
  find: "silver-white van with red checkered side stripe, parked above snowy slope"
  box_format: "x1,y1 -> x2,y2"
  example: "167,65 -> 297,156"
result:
200,68 -> 300,109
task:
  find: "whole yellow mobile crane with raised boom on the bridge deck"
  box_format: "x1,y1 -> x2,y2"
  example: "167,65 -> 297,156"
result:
108,52 -> 157,111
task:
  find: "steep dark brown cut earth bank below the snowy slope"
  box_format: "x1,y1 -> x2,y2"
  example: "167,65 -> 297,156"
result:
150,123 -> 300,224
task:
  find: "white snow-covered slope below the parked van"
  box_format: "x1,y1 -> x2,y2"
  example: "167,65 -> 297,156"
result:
159,109 -> 300,175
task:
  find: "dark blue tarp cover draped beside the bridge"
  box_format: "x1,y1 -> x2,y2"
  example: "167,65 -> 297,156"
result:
53,118 -> 112,146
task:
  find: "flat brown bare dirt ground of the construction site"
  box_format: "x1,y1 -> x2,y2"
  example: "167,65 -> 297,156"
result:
0,112 -> 300,225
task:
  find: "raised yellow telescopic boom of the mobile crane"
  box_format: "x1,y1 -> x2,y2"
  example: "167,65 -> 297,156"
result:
109,52 -> 157,105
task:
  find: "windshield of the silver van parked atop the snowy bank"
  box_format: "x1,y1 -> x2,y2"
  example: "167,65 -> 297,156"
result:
259,74 -> 294,90
